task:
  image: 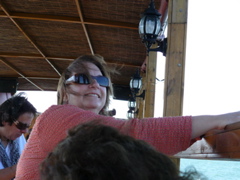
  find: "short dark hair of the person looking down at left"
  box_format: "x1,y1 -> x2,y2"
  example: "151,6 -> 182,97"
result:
0,93 -> 37,126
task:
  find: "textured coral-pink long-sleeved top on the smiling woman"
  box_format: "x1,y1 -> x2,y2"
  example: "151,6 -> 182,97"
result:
15,105 -> 192,180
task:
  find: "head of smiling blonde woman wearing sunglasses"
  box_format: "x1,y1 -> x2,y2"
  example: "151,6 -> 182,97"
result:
57,55 -> 112,115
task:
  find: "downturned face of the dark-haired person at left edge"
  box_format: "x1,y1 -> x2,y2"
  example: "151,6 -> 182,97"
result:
1,112 -> 34,140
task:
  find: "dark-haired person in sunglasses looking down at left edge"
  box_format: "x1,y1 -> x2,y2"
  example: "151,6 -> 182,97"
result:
0,94 -> 37,180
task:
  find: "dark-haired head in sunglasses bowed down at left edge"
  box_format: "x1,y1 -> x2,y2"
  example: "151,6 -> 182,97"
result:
0,93 -> 37,140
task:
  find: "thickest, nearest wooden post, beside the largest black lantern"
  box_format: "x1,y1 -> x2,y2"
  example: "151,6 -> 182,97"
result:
163,0 -> 188,166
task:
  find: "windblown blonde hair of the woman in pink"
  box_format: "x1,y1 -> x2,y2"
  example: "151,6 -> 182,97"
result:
57,55 -> 113,115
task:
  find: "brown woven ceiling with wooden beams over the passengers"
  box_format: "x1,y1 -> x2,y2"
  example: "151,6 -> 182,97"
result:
0,0 -> 166,99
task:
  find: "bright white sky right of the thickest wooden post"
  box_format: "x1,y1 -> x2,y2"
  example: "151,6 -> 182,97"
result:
184,0 -> 240,115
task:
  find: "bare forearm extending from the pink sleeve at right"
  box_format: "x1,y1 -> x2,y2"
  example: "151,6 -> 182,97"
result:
192,111 -> 240,138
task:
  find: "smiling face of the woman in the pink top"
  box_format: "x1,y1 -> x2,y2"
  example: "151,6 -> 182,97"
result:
67,63 -> 107,114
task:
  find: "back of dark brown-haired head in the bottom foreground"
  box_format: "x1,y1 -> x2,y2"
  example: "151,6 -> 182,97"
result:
41,123 -> 203,180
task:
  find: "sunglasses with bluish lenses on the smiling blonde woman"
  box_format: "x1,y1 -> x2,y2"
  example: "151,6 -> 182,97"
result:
66,74 -> 109,87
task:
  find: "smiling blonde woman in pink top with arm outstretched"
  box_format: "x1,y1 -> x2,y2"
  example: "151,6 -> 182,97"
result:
16,55 -> 240,180
